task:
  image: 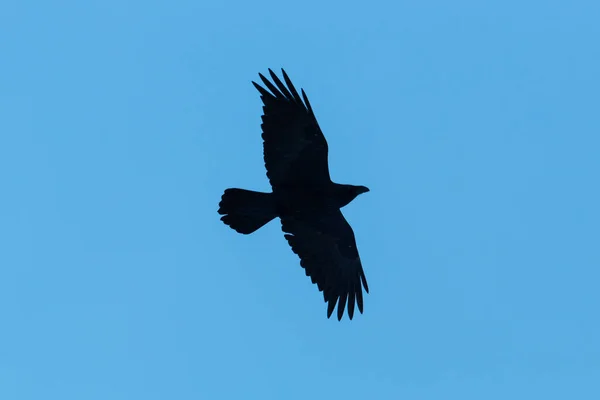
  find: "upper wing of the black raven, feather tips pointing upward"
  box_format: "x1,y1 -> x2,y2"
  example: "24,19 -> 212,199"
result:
252,69 -> 331,188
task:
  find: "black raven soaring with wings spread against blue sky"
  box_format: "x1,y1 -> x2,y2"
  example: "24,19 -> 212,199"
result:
218,68 -> 369,321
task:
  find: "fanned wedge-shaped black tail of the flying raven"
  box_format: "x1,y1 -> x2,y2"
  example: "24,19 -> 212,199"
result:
219,189 -> 277,235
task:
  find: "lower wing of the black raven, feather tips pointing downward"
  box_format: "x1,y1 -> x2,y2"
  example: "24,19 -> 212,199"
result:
281,209 -> 369,320
